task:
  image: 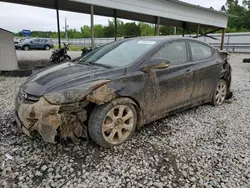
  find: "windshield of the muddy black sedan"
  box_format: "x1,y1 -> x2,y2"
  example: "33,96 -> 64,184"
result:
79,39 -> 157,67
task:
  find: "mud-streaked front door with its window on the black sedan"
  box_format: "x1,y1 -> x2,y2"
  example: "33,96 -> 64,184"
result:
143,40 -> 194,117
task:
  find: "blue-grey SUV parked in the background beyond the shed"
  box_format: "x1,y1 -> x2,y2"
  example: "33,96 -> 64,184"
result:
16,38 -> 54,51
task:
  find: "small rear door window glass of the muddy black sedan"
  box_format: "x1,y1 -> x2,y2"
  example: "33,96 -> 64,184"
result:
189,42 -> 213,61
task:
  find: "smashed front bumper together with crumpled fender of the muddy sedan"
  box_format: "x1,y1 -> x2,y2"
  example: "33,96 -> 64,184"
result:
15,80 -> 116,143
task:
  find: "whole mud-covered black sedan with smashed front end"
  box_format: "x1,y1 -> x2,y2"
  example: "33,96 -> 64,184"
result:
15,37 -> 231,147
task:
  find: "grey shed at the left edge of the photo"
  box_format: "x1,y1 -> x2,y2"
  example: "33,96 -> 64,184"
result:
0,28 -> 18,71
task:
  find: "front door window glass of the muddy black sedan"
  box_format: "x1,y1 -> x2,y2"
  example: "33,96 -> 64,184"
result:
152,42 -> 188,65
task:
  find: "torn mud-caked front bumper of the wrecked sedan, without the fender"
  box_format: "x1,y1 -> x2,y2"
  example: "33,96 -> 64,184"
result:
15,97 -> 87,143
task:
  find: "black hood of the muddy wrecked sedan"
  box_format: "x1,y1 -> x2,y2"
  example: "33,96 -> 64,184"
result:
21,63 -> 125,96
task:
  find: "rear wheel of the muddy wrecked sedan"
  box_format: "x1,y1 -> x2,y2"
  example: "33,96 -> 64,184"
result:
212,79 -> 228,106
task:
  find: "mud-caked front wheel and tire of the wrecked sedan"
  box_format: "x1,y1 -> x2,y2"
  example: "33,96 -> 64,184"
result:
88,102 -> 137,148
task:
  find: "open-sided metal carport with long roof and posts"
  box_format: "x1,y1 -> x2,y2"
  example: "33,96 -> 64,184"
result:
0,0 -> 228,49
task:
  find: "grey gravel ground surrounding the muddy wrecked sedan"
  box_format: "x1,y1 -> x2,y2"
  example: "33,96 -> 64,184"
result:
0,55 -> 250,188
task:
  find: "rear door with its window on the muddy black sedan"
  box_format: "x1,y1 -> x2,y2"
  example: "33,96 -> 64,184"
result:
189,41 -> 222,101
